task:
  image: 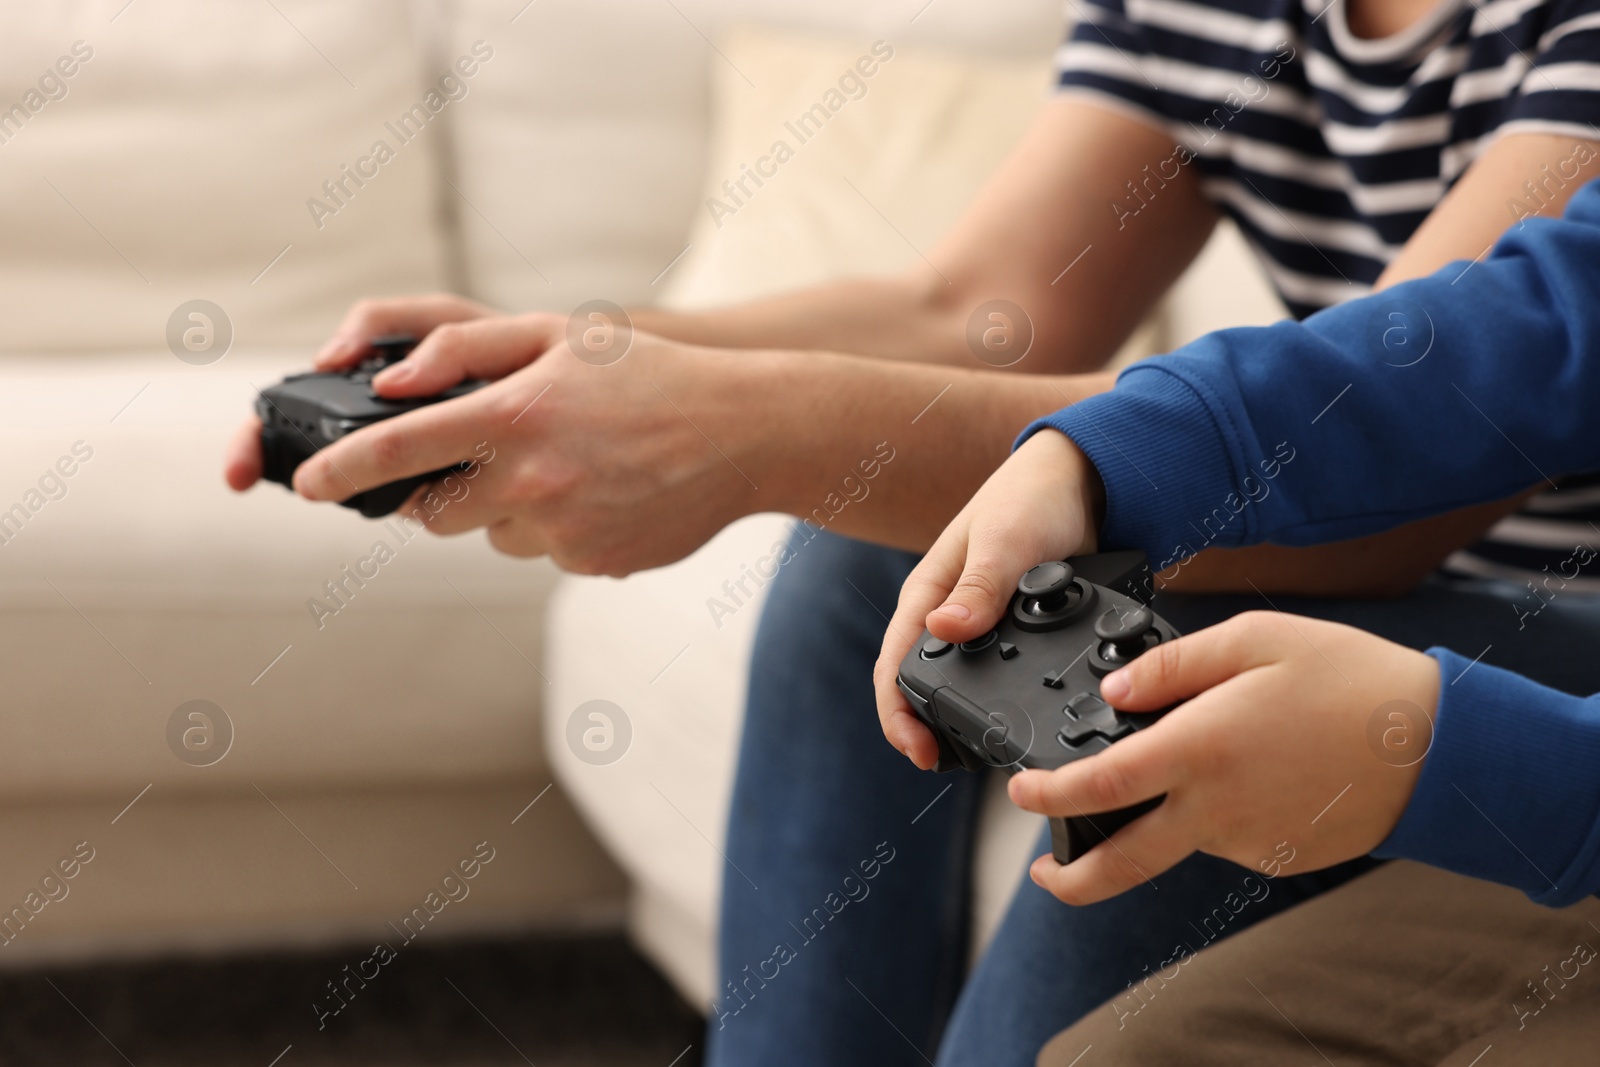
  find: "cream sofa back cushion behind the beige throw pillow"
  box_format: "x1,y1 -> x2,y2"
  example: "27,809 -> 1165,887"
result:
451,0 -> 1061,312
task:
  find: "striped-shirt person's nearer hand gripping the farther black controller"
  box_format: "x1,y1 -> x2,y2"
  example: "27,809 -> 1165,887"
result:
256,315 -> 774,576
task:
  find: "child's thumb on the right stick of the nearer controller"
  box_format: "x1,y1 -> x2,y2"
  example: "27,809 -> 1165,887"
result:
1101,611 -> 1294,712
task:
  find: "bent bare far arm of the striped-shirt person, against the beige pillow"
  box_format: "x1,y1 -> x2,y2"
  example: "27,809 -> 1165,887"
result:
634,98 -> 1216,374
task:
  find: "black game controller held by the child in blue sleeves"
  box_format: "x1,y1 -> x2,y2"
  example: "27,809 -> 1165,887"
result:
899,552 -> 1178,864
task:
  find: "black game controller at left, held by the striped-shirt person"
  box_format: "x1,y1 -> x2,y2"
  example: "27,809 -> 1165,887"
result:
256,334 -> 485,518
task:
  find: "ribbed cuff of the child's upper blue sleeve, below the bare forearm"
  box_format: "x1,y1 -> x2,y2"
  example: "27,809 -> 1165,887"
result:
1016,357 -> 1267,571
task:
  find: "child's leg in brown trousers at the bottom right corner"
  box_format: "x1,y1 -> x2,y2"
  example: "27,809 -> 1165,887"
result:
1038,862 -> 1600,1067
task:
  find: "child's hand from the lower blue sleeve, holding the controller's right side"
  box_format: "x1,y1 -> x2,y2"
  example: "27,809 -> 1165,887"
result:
1010,611 -> 1438,904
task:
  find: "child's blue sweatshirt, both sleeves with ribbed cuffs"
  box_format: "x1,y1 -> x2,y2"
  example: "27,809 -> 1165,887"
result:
1018,181 -> 1600,905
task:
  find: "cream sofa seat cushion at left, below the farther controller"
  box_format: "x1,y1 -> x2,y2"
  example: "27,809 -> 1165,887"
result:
0,352 -> 552,803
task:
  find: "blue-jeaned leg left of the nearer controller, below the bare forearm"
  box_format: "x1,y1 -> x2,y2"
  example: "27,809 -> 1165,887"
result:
707,526 -> 981,1067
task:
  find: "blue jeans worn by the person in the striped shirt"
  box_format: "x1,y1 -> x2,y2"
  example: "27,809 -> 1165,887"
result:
706,528 -> 1600,1067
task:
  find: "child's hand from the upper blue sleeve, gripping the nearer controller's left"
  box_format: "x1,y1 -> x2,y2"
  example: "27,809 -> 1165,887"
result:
874,430 -> 1104,769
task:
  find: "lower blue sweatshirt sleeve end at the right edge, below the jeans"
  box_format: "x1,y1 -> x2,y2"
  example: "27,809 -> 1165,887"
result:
1373,648 -> 1600,907
